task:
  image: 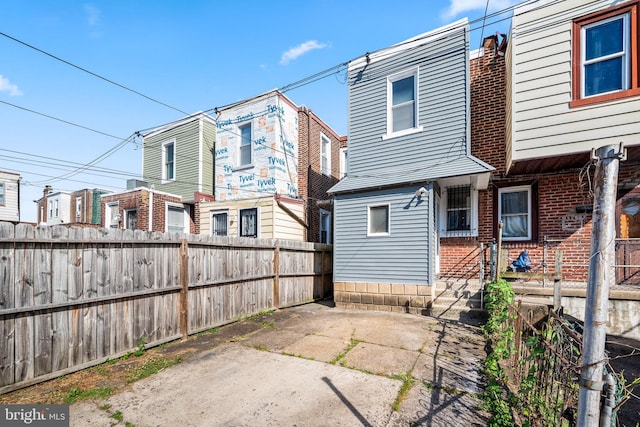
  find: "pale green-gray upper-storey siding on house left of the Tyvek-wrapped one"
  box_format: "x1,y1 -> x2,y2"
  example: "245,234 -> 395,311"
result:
143,118 -> 206,201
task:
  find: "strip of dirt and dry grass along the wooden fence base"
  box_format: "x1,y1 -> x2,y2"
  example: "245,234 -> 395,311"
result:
0,311 -> 282,404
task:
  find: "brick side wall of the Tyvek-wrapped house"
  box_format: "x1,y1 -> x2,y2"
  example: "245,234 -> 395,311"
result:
298,107 -> 347,242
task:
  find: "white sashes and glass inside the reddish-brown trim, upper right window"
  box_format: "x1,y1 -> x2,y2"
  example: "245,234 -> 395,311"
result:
580,13 -> 630,97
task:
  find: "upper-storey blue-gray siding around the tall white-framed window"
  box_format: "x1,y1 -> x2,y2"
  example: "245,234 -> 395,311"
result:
348,27 -> 468,182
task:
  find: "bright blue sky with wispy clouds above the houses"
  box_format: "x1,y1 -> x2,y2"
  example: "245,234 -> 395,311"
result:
0,0 -> 517,221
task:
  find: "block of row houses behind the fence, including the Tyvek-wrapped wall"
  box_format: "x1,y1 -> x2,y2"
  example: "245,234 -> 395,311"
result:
136,90 -> 346,243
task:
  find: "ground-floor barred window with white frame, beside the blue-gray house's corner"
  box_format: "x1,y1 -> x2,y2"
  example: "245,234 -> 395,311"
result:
439,185 -> 478,237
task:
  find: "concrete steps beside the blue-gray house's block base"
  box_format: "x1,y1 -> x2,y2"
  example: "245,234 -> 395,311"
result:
429,281 -> 486,320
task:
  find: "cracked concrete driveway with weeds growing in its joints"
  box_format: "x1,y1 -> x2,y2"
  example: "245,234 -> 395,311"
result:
70,303 -> 488,427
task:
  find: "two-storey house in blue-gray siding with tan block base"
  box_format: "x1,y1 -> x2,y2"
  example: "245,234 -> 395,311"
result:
330,20 -> 494,311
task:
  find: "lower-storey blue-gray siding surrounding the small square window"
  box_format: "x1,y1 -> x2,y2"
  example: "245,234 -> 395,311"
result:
334,185 -> 434,285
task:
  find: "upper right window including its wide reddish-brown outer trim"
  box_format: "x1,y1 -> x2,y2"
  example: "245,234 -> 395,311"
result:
571,1 -> 640,106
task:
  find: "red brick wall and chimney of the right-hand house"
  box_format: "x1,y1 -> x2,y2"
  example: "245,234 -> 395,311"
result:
439,38 -> 640,282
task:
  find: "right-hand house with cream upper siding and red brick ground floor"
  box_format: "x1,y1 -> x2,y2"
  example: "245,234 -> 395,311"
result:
441,0 -> 640,284
